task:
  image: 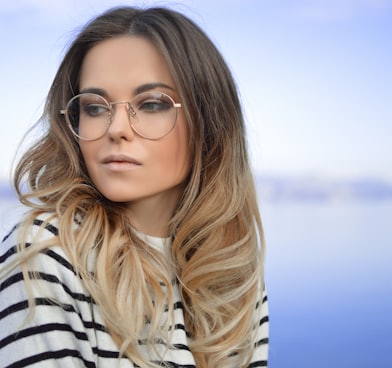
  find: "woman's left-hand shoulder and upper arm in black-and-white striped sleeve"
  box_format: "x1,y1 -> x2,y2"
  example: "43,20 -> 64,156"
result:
0,214 -> 105,367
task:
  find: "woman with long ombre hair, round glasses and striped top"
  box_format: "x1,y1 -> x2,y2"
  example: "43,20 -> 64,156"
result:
0,7 -> 268,368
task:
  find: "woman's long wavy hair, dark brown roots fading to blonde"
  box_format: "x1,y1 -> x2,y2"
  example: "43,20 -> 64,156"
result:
14,7 -> 264,367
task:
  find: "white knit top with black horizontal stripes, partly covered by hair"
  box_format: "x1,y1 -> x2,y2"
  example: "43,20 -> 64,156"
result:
0,219 -> 268,368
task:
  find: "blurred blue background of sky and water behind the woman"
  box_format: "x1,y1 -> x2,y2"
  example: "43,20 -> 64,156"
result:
0,0 -> 392,368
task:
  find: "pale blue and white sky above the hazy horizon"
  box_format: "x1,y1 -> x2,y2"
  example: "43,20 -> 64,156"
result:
0,0 -> 392,181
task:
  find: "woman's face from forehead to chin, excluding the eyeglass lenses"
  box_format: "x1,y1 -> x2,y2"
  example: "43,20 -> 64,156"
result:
79,36 -> 190,218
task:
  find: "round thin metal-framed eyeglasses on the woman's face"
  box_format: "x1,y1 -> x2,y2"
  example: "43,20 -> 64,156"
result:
60,91 -> 181,141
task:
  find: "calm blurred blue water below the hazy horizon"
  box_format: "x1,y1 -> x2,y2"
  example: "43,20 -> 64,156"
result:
0,198 -> 392,368
